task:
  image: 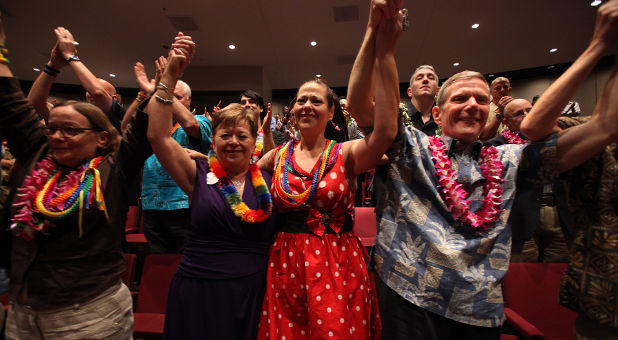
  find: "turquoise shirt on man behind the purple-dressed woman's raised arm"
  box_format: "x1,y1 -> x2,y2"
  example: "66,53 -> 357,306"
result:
141,115 -> 212,210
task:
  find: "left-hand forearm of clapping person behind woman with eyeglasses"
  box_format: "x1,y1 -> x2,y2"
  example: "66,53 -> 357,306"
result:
28,42 -> 67,120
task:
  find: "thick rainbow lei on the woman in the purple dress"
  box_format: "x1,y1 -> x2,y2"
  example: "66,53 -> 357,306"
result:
206,150 -> 272,223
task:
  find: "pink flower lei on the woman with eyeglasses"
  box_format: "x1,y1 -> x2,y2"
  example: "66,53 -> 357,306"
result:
11,156 -> 83,241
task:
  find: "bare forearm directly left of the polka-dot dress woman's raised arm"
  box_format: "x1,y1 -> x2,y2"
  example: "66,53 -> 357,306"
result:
347,26 -> 376,127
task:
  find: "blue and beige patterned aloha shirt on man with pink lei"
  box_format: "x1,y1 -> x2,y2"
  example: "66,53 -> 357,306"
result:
373,127 -> 556,327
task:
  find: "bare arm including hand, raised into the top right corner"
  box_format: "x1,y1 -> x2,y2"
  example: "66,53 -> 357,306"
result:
521,0 -> 618,141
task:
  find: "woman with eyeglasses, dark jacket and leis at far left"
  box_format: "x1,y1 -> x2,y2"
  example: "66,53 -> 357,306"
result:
0,14 -> 151,339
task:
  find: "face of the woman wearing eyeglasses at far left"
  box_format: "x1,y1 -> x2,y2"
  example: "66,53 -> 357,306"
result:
47,106 -> 108,167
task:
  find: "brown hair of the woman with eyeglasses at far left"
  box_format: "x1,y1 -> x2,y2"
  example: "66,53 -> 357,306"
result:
54,100 -> 122,156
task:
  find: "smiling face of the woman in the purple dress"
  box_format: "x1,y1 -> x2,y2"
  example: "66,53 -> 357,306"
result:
212,119 -> 255,170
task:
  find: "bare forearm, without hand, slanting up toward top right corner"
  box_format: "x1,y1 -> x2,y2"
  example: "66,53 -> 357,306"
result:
521,43 -> 605,141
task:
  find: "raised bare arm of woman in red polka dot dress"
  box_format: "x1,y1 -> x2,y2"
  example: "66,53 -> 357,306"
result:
343,0 -> 402,175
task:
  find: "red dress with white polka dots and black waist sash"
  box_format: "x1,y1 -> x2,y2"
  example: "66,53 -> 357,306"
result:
258,139 -> 381,339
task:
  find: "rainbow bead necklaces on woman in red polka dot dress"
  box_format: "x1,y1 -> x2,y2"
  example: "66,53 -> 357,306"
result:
273,140 -> 341,208
